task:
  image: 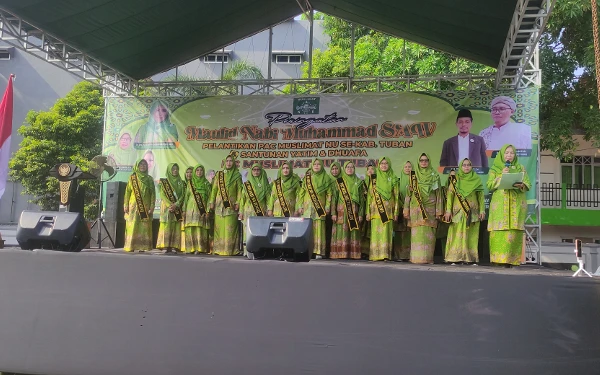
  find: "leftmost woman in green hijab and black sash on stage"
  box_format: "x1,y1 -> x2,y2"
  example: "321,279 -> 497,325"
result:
123,159 -> 156,252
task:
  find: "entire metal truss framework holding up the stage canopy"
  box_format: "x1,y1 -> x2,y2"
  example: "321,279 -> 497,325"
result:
0,0 -> 544,264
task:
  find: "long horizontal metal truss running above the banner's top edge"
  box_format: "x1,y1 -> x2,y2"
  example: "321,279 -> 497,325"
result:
116,73 -> 495,96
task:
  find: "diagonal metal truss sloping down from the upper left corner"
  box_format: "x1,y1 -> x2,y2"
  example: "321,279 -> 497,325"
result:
0,8 -> 137,94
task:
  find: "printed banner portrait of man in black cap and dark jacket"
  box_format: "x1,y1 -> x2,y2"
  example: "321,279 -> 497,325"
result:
440,109 -> 488,168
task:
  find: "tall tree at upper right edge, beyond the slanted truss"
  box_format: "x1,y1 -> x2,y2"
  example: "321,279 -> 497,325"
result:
540,0 -> 600,159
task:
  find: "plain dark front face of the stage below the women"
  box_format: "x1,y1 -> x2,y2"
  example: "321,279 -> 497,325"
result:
0,250 -> 600,375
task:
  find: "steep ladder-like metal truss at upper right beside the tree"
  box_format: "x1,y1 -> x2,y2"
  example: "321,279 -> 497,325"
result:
496,0 -> 556,90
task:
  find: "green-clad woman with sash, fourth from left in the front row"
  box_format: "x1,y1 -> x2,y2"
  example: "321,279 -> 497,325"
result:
210,155 -> 244,256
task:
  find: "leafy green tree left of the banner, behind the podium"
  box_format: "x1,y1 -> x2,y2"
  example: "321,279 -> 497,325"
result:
9,81 -> 104,219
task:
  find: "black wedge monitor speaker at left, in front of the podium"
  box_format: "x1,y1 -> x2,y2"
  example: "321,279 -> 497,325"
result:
17,211 -> 91,251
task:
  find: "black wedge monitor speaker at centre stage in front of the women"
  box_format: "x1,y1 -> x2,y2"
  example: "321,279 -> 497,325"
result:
245,216 -> 313,261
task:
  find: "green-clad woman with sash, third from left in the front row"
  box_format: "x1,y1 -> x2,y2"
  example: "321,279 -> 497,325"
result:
181,164 -> 212,254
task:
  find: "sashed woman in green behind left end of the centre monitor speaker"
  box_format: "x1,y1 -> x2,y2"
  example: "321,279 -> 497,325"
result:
238,163 -> 271,256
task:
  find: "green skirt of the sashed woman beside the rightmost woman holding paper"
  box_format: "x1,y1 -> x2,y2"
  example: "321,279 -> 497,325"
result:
444,222 -> 479,263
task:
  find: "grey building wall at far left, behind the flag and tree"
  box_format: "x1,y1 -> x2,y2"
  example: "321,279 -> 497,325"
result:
0,44 -> 78,224
